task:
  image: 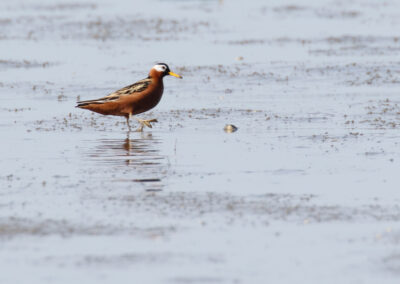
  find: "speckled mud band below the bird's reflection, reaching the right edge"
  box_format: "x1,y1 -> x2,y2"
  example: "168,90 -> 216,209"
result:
108,192 -> 400,224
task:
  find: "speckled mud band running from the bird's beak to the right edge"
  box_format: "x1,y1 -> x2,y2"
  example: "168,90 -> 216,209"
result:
180,62 -> 400,88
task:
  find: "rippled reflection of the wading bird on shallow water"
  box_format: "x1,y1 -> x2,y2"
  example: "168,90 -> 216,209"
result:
89,132 -> 168,191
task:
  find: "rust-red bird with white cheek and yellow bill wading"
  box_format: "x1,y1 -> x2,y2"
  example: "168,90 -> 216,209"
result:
76,63 -> 182,132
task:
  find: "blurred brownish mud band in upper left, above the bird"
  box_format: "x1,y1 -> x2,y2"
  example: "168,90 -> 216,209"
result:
0,14 -> 210,42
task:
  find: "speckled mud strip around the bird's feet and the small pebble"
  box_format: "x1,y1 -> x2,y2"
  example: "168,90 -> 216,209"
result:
24,108 -> 336,133
